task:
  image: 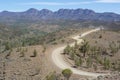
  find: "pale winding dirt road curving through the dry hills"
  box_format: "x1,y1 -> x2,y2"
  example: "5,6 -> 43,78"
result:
52,28 -> 106,77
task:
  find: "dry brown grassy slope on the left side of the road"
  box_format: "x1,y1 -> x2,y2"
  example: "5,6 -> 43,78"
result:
0,29 -> 93,80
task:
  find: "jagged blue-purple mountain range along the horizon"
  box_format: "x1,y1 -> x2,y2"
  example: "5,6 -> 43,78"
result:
0,8 -> 120,23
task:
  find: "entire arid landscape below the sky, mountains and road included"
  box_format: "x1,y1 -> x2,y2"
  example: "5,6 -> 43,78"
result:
0,8 -> 120,80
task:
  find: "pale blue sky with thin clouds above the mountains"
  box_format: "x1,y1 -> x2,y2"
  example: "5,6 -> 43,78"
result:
0,0 -> 120,14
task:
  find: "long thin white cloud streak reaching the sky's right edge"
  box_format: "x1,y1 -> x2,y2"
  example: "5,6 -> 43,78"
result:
20,0 -> 120,6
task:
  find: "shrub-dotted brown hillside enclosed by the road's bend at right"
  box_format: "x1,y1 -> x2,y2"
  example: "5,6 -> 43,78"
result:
63,31 -> 120,72
